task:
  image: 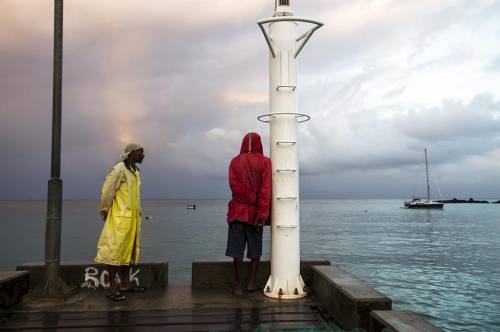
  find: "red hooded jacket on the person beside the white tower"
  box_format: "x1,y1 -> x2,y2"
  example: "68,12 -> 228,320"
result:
227,133 -> 272,225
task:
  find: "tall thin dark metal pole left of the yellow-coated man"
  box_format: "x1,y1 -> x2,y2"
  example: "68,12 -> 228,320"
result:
41,0 -> 65,296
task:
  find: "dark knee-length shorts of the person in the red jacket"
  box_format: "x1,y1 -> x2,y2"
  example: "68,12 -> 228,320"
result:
226,221 -> 264,259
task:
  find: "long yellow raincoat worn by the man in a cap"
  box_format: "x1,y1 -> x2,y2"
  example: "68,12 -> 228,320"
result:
95,162 -> 142,266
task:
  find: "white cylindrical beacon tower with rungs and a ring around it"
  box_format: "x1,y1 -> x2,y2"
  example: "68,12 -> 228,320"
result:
257,0 -> 323,299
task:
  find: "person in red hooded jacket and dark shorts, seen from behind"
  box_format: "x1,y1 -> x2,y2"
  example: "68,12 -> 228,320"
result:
226,133 -> 272,296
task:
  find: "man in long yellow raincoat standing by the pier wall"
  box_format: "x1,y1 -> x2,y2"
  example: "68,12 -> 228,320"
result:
95,143 -> 144,301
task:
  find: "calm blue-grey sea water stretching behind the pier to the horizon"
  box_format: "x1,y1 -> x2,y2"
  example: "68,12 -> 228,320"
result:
0,200 -> 500,331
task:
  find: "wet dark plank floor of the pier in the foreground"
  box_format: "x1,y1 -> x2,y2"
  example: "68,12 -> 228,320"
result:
0,285 -> 340,331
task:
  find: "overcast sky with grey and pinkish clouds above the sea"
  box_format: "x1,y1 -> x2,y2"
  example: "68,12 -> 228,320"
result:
0,0 -> 500,199
